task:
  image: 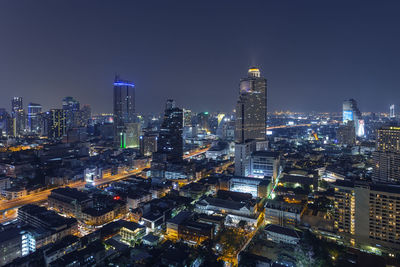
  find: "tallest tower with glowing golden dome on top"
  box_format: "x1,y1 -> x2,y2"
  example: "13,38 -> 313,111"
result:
235,68 -> 267,143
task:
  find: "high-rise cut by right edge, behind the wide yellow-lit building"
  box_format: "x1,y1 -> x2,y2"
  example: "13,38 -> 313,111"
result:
372,126 -> 400,183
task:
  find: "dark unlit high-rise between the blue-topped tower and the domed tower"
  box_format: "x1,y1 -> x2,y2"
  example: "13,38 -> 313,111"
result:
157,99 -> 183,162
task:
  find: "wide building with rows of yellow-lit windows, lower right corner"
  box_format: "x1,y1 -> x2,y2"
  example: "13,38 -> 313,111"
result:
333,181 -> 400,251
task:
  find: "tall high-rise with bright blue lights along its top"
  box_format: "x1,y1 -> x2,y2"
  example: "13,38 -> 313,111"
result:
114,75 -> 137,148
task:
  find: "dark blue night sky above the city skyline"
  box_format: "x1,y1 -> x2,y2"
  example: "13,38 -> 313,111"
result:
0,0 -> 400,113
